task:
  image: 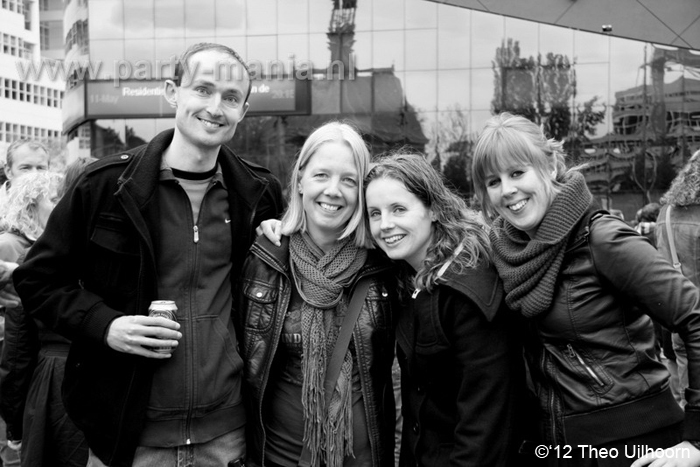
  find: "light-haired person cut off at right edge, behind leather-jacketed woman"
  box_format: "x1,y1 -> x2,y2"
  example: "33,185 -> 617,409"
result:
656,150 -> 700,406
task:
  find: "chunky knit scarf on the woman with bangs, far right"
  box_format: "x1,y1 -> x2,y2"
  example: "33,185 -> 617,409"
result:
490,172 -> 593,318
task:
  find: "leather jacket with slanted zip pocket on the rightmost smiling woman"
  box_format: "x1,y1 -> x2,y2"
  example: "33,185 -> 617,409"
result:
527,208 -> 700,445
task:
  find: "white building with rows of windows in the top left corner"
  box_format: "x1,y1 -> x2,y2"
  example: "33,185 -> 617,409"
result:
0,0 -> 65,167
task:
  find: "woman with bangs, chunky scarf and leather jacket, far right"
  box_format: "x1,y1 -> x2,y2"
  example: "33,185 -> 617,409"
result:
472,113 -> 700,467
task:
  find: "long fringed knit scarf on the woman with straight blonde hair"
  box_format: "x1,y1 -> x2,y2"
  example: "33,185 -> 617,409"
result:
289,233 -> 367,467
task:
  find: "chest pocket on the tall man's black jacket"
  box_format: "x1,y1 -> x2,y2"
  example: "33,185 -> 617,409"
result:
86,214 -> 140,296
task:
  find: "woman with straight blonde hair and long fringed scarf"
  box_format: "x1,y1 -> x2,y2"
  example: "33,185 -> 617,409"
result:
238,122 -> 396,467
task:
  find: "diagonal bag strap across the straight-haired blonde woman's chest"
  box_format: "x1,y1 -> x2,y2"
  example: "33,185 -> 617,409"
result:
299,278 -> 370,467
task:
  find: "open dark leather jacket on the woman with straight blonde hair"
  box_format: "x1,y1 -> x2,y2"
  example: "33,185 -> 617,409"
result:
237,237 -> 397,467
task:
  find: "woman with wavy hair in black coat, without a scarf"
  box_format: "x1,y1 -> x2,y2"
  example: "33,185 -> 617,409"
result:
365,152 -> 524,466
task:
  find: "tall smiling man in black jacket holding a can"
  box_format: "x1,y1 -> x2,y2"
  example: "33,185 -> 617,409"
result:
14,43 -> 283,467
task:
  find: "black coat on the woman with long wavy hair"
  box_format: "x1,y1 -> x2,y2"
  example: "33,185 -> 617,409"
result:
396,264 -> 526,467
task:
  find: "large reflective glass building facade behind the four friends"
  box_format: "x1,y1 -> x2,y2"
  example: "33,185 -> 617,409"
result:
64,0 -> 700,217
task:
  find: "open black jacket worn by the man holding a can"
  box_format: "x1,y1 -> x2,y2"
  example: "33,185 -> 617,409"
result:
14,130 -> 282,466
